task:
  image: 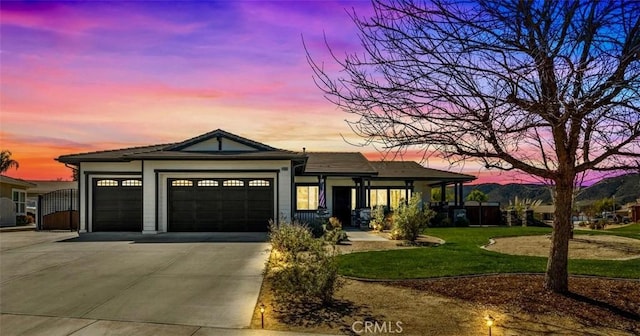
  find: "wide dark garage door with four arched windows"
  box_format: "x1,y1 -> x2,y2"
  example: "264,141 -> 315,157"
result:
167,178 -> 274,232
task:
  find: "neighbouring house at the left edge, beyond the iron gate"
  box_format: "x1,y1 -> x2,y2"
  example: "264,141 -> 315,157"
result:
0,175 -> 35,226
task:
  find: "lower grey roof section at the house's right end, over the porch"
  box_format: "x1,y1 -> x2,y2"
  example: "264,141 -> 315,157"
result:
370,161 -> 476,182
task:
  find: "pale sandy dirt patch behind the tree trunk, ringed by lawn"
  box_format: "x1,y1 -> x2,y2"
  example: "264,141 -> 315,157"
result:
485,234 -> 640,260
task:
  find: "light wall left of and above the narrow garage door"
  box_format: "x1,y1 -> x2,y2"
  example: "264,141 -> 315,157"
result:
78,161 -> 144,232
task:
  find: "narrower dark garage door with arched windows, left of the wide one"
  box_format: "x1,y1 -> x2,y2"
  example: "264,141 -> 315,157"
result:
92,178 -> 142,232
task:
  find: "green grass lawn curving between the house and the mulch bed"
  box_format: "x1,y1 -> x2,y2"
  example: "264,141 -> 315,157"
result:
338,227 -> 640,279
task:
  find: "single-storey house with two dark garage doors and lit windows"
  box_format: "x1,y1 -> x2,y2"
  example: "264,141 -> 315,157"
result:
57,130 -> 475,233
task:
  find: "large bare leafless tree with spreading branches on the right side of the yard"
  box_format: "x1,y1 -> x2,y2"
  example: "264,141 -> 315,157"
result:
307,0 -> 640,292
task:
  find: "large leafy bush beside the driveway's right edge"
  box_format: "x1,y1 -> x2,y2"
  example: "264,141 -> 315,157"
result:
267,223 -> 342,303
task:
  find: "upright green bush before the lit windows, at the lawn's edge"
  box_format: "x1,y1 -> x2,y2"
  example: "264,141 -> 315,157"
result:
391,193 -> 435,241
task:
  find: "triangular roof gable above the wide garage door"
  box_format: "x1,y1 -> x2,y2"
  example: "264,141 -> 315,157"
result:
165,129 -> 276,152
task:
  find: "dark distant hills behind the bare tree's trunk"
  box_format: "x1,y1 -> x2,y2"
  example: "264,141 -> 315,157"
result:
464,174 -> 640,205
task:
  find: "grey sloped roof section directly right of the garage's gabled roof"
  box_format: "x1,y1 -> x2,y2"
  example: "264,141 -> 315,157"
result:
304,152 -> 377,176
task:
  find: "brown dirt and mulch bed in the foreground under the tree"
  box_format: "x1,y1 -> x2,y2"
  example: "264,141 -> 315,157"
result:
251,236 -> 640,336
